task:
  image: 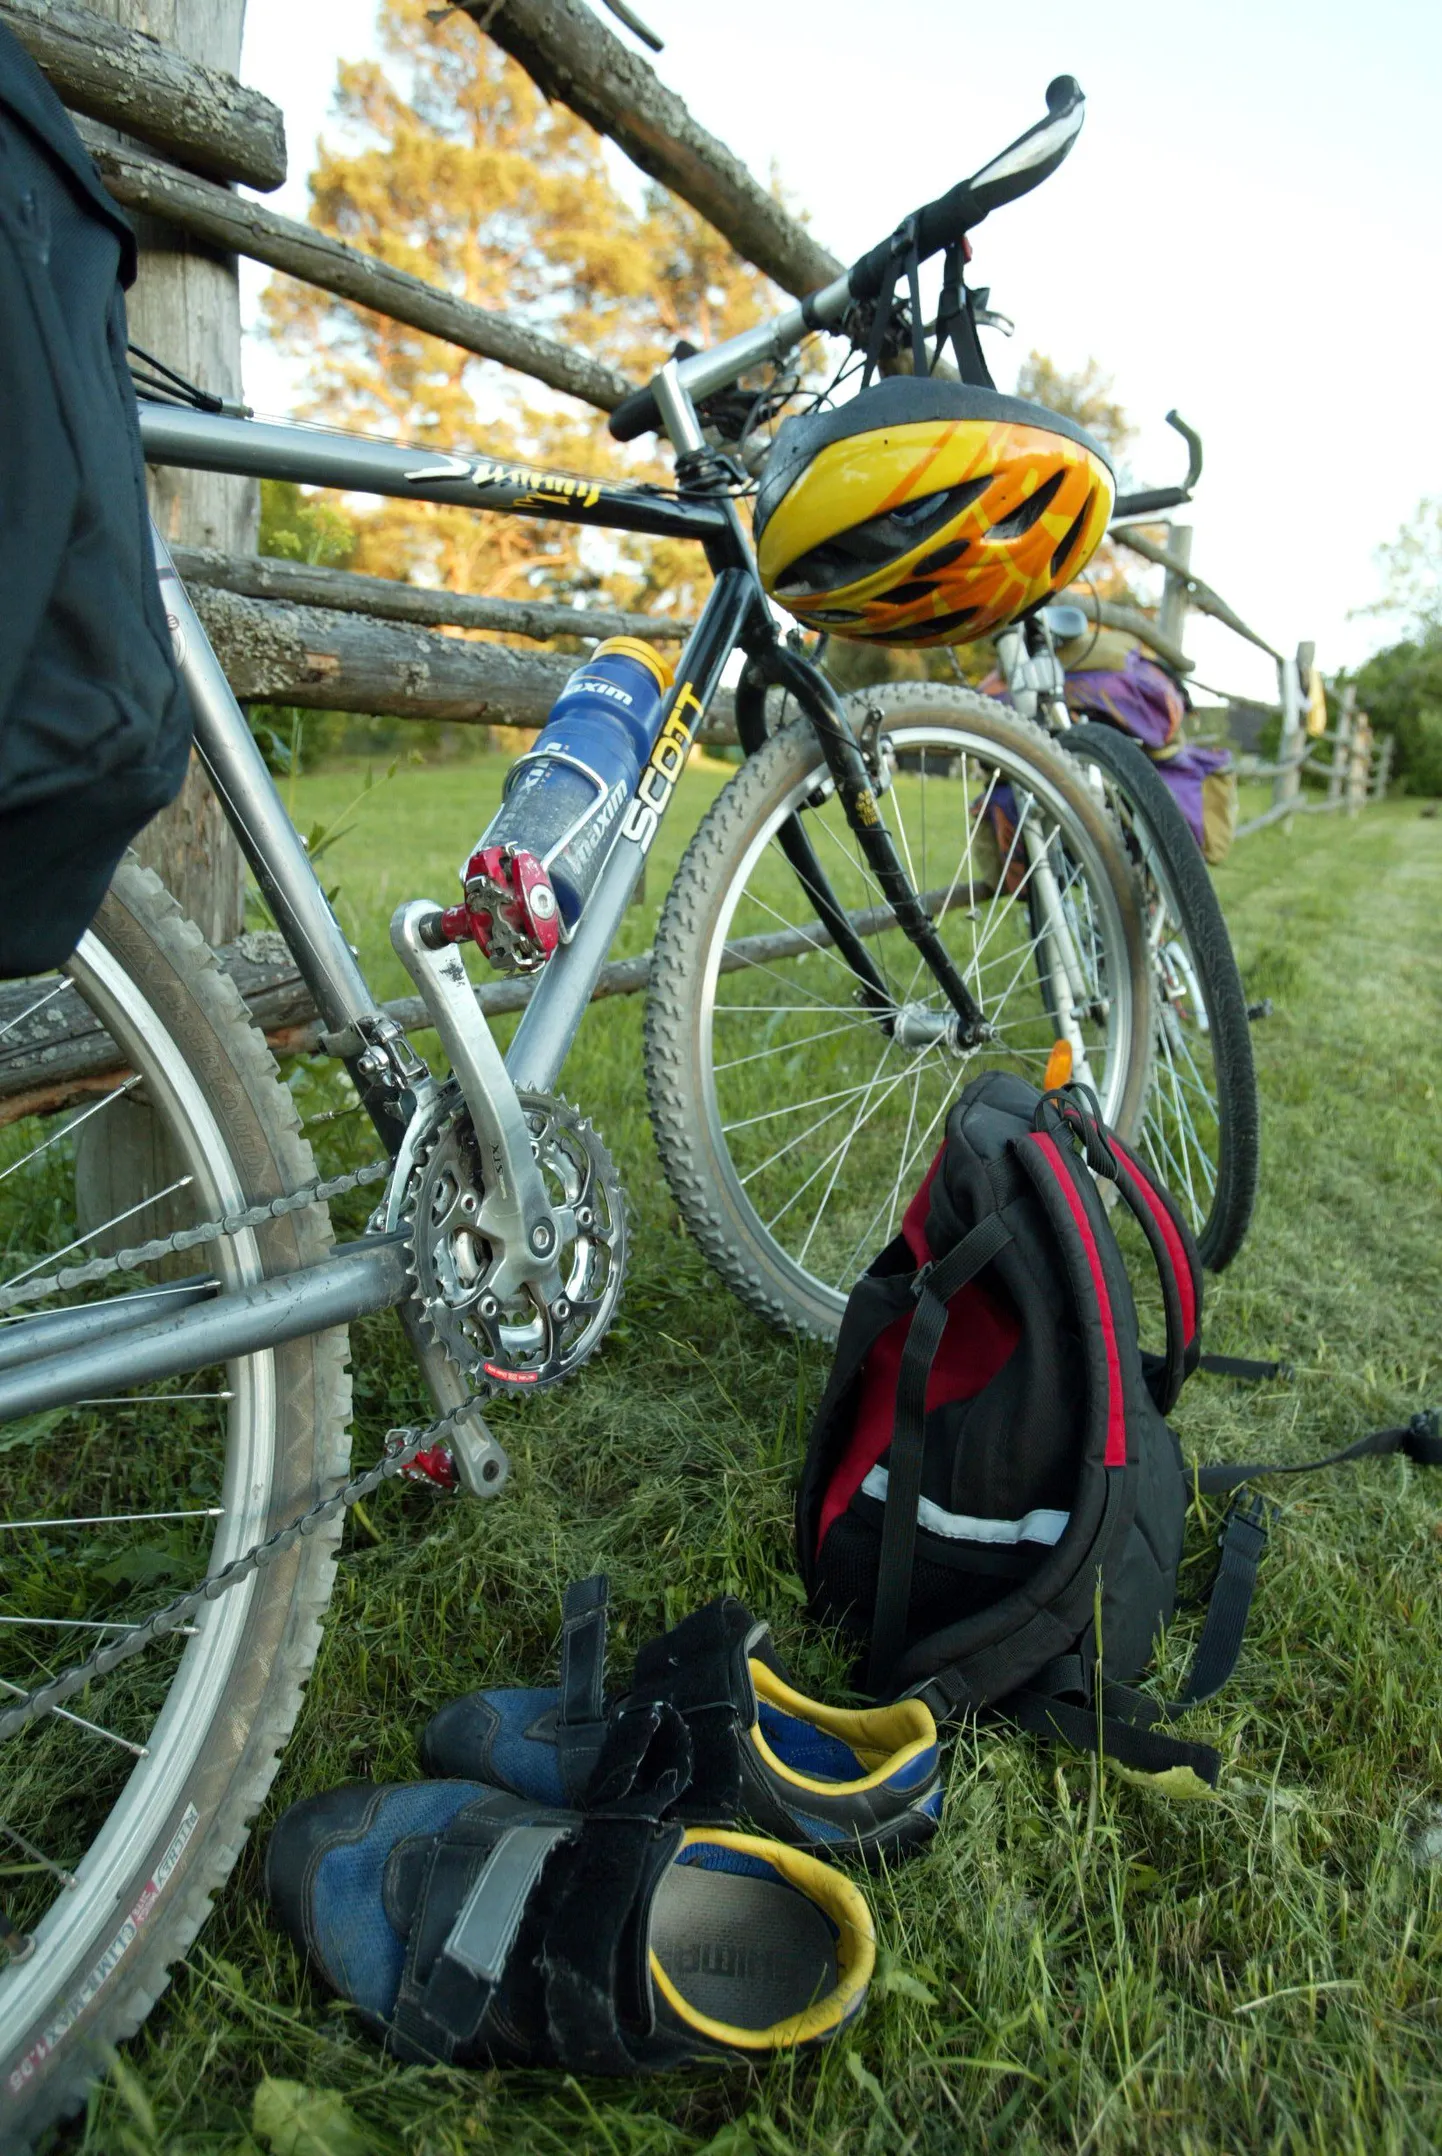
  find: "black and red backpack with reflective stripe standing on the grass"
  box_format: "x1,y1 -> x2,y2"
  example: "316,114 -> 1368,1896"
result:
798,1072 -> 1442,1785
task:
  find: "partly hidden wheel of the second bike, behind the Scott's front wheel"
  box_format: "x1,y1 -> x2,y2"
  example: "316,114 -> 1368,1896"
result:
1060,722 -> 1261,1272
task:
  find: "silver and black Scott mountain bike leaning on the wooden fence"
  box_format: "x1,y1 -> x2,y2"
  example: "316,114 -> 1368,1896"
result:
0,78 -> 1155,2139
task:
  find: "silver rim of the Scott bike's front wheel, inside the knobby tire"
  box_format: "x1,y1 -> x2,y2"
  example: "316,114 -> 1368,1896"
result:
698,720 -> 1134,1324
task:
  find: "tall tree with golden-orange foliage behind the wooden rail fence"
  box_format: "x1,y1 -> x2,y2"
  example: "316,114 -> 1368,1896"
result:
257,0 -> 778,629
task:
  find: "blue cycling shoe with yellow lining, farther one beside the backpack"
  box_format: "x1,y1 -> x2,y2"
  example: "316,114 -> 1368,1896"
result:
420,1576 -> 942,1861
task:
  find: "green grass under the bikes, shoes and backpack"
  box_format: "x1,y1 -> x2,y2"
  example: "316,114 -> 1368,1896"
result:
22,765 -> 1442,2156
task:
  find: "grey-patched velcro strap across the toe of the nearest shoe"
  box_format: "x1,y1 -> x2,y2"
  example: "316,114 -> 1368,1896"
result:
394,1813 -> 578,2061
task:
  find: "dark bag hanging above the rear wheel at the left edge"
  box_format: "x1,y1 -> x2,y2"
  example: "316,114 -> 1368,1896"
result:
0,24 -> 190,977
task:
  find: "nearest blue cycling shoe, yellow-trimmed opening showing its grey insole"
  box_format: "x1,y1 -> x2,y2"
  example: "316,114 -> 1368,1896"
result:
265,1767 -> 875,2074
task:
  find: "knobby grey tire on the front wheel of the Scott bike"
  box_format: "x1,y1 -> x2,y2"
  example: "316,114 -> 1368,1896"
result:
647,681 -> 1151,1339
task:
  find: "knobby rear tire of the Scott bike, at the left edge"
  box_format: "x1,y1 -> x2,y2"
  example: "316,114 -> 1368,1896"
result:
0,860 -> 349,2150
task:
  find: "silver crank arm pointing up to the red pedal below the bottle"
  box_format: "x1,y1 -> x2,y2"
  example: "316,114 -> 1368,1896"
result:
390,899 -> 563,1304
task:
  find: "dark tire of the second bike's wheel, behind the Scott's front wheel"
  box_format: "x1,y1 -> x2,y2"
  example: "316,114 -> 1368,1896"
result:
1058,720 -> 1261,1272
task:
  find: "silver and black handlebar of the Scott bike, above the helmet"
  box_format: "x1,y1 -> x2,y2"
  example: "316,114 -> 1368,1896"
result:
608,75 -> 1086,442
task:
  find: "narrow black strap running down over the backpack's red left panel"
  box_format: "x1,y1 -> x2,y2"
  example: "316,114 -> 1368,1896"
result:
869,1212 -> 1013,1692
